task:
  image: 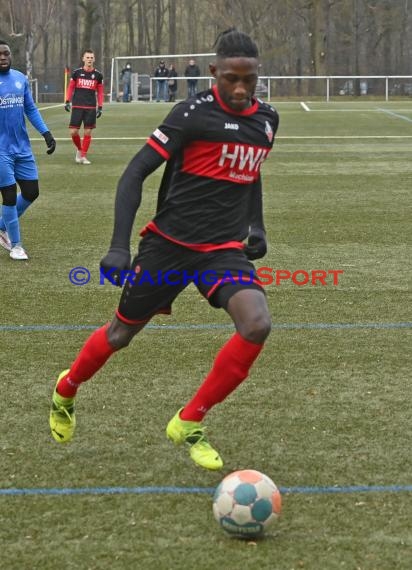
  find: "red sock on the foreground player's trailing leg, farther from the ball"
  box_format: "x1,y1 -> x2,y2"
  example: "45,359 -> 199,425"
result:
57,325 -> 116,398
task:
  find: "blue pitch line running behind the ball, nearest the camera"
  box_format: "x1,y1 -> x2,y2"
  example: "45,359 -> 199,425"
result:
0,485 -> 412,497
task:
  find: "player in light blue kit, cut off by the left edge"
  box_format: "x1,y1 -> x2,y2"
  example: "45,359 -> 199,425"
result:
0,40 -> 56,260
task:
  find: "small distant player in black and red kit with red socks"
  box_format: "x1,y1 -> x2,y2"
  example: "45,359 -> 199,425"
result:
64,49 -> 104,164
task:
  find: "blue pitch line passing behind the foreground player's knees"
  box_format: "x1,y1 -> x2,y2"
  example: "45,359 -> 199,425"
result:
0,321 -> 412,332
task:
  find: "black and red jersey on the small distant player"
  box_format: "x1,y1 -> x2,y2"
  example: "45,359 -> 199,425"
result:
66,67 -> 103,109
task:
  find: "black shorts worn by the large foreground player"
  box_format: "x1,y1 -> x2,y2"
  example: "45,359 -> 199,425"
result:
116,232 -> 263,324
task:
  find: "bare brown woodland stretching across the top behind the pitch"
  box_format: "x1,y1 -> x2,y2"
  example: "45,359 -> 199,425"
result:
0,0 -> 412,95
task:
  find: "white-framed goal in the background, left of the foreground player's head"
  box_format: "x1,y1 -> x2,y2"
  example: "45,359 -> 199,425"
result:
109,53 -> 216,103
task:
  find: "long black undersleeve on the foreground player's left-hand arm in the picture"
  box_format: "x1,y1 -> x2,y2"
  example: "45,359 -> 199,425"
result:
110,144 -> 165,250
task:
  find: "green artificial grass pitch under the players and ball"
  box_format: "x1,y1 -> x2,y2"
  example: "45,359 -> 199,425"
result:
0,101 -> 412,570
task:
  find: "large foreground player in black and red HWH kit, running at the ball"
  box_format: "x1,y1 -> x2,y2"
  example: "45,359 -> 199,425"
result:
50,29 -> 279,470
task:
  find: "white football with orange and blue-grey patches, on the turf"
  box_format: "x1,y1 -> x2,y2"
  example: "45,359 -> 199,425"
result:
213,469 -> 282,538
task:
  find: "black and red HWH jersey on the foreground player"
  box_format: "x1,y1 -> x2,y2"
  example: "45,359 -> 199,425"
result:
146,86 -> 279,250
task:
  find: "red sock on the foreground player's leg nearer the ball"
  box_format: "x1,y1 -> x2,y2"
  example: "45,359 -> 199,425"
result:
180,333 -> 263,422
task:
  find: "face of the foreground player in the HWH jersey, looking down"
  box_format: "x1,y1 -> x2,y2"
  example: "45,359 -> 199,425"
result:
210,57 -> 258,111
